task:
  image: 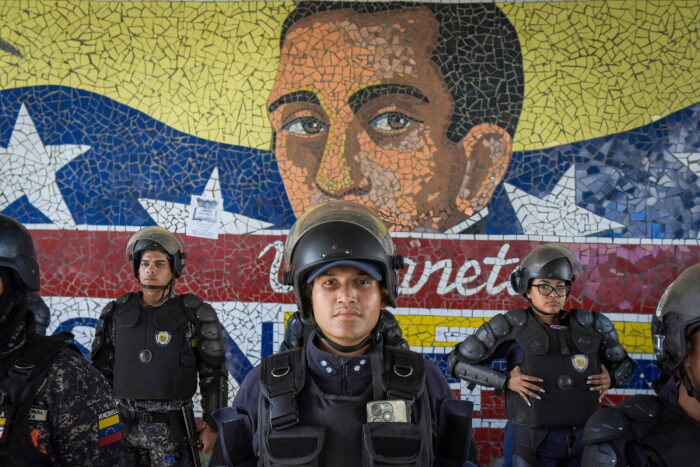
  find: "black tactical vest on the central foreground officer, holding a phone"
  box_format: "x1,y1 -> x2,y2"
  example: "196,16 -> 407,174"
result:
258,346 -> 433,467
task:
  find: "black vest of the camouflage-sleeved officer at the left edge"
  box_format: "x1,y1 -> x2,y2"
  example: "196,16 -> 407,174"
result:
0,332 -> 80,467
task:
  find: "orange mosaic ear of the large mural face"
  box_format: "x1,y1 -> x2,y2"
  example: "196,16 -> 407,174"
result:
457,123 -> 513,216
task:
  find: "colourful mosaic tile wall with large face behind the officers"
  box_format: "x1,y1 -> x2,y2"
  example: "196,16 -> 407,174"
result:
0,0 -> 700,463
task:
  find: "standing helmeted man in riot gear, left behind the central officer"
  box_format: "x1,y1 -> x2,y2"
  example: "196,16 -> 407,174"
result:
91,227 -> 227,466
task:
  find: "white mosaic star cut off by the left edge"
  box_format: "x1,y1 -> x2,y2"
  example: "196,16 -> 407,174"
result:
0,104 -> 90,228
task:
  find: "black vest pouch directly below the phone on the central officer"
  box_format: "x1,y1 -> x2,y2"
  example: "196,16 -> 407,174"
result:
362,422 -> 423,467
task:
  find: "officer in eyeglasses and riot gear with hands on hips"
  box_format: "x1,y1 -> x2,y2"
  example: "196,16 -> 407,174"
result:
448,244 -> 634,467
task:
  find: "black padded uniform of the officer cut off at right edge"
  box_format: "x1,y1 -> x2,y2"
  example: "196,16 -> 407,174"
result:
583,380 -> 700,467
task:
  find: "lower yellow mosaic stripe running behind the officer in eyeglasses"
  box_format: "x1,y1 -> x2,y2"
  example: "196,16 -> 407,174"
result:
396,315 -> 654,353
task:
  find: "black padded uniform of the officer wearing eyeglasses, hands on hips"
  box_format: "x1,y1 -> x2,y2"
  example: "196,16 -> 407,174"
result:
450,308 -> 634,466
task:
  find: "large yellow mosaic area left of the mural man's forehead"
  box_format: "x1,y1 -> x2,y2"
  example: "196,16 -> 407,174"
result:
0,0 -> 292,149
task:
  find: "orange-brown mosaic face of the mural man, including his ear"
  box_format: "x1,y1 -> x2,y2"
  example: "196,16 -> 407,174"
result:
268,7 -> 511,231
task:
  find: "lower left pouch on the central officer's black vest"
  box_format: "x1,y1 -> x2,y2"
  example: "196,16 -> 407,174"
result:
264,425 -> 325,467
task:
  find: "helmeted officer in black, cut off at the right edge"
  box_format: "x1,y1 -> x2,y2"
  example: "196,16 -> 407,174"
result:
583,263 -> 700,467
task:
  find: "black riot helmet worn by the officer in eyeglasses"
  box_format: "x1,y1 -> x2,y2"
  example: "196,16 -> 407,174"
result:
510,243 -> 583,294
